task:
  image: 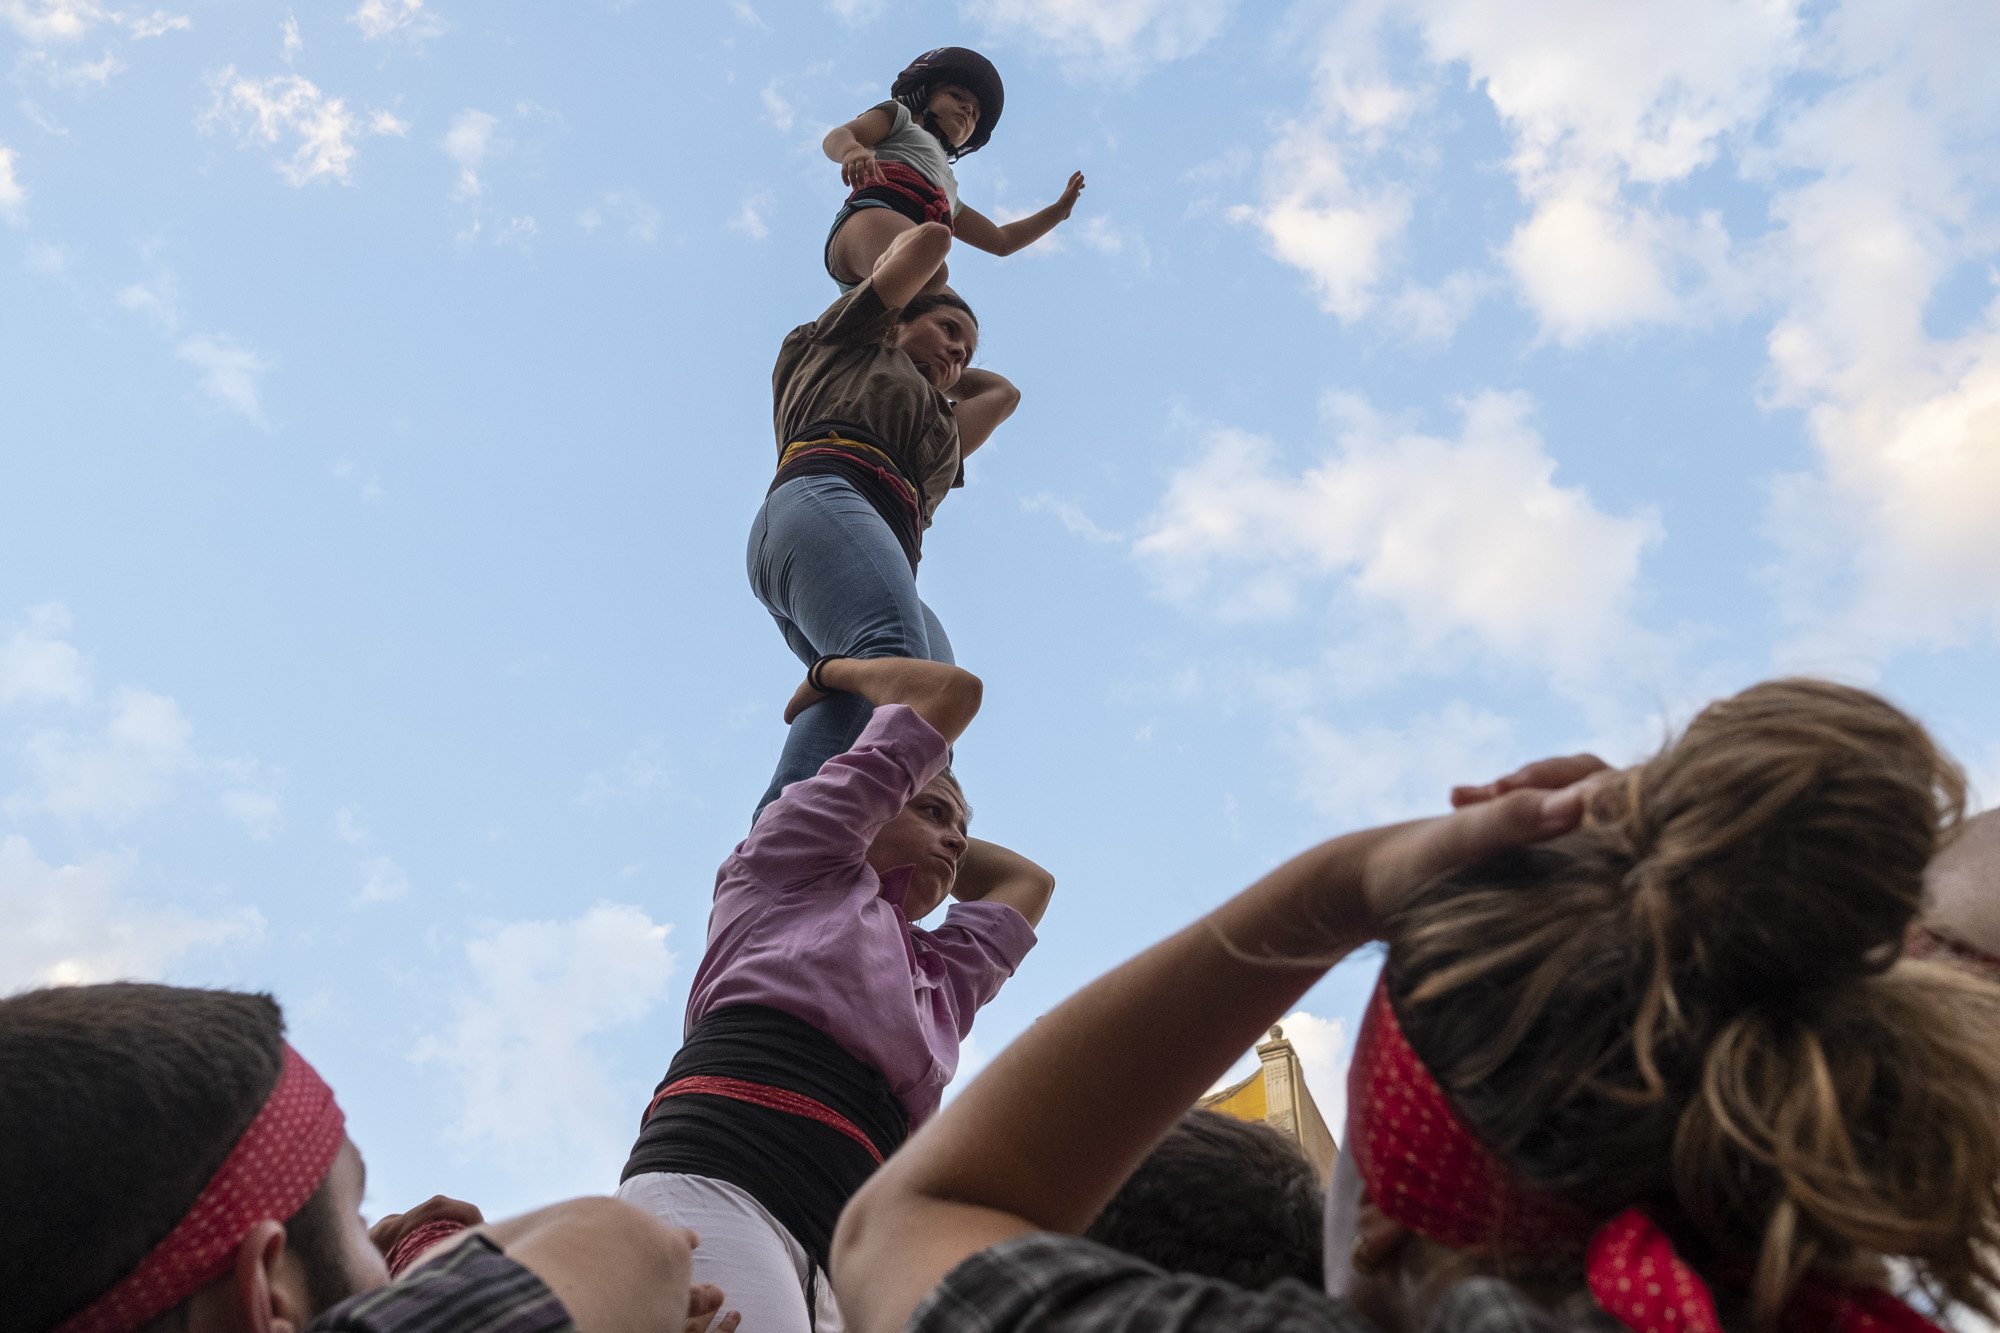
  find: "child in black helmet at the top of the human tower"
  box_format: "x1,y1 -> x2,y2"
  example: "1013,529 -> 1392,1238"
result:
822,46 -> 1084,290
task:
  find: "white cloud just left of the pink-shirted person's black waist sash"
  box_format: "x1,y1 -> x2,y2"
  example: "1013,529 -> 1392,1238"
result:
412,903 -> 674,1179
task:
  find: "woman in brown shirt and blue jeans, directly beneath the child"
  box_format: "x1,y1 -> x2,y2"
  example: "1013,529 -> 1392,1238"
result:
748,222 -> 1020,811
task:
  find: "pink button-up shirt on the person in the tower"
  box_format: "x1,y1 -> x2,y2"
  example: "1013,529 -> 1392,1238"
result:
688,705 -> 1034,1129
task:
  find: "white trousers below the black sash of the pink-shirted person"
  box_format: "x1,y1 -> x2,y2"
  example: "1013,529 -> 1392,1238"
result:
618,1171 -> 842,1333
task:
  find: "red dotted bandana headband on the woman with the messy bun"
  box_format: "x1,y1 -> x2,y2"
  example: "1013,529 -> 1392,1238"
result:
1344,983 -> 1942,1333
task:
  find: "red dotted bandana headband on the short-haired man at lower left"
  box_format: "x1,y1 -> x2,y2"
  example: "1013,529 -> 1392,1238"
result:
56,1047 -> 346,1333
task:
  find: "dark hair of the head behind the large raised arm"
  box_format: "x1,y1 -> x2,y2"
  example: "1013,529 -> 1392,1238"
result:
1084,1111 -> 1326,1289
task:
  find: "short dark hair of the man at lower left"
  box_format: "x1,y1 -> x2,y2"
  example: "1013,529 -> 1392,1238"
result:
0,983 -> 348,1331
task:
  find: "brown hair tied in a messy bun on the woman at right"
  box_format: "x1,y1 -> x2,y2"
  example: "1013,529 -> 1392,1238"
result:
1386,679 -> 2000,1327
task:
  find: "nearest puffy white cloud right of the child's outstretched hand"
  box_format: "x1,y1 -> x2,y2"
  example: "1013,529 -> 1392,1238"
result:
1230,124 -> 1410,320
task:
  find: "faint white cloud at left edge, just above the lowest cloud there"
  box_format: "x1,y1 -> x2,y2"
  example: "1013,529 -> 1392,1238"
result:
6,687 -> 196,825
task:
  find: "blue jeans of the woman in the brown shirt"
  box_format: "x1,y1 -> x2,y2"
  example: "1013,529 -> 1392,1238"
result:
748,476 -> 952,815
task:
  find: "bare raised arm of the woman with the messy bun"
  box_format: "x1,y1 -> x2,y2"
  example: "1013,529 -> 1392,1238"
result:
832,789 -> 1584,1333
